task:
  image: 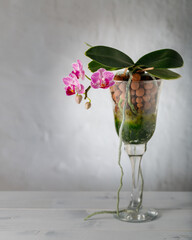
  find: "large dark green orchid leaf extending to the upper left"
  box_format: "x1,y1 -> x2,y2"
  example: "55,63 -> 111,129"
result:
85,46 -> 134,68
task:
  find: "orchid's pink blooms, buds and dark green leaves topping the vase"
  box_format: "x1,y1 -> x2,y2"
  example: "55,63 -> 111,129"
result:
63,44 -> 183,109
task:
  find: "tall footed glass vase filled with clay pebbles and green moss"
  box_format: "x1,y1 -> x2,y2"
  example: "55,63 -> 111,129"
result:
110,74 -> 162,222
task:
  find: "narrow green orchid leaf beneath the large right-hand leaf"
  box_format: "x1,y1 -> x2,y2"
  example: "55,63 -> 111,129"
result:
147,68 -> 181,80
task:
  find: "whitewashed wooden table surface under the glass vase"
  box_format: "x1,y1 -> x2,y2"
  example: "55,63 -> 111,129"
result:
0,192 -> 192,240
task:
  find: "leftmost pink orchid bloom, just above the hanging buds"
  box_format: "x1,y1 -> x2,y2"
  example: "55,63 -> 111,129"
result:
63,73 -> 85,96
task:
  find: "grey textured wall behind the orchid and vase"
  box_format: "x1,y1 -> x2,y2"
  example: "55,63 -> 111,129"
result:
0,0 -> 192,190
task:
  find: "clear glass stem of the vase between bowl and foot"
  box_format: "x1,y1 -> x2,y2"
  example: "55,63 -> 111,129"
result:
125,144 -> 146,211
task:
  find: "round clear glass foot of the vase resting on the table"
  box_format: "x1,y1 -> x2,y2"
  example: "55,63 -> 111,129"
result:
114,208 -> 158,223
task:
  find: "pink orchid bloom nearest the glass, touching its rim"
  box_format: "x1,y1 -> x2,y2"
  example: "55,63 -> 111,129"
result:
91,68 -> 115,89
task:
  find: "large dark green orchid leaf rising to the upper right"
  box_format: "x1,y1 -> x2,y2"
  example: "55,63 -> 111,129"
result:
135,49 -> 183,68
